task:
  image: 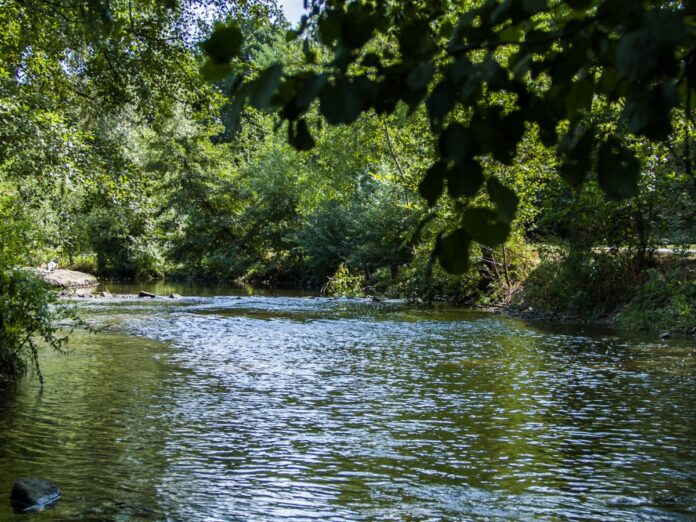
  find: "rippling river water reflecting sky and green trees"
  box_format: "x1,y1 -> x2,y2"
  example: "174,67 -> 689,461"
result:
0,289 -> 696,521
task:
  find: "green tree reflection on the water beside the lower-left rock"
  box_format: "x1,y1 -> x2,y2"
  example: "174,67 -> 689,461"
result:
0,332 -> 175,518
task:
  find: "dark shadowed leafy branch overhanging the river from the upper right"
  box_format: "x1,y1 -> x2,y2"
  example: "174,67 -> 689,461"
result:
202,0 -> 696,273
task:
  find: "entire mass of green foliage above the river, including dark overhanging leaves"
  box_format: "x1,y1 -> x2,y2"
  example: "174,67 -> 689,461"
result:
0,0 -> 696,382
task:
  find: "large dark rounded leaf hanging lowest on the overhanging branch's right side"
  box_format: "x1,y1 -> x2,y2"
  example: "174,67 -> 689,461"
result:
597,138 -> 640,201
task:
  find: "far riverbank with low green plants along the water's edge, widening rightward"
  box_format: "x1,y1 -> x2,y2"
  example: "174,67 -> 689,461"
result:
59,245 -> 696,336
